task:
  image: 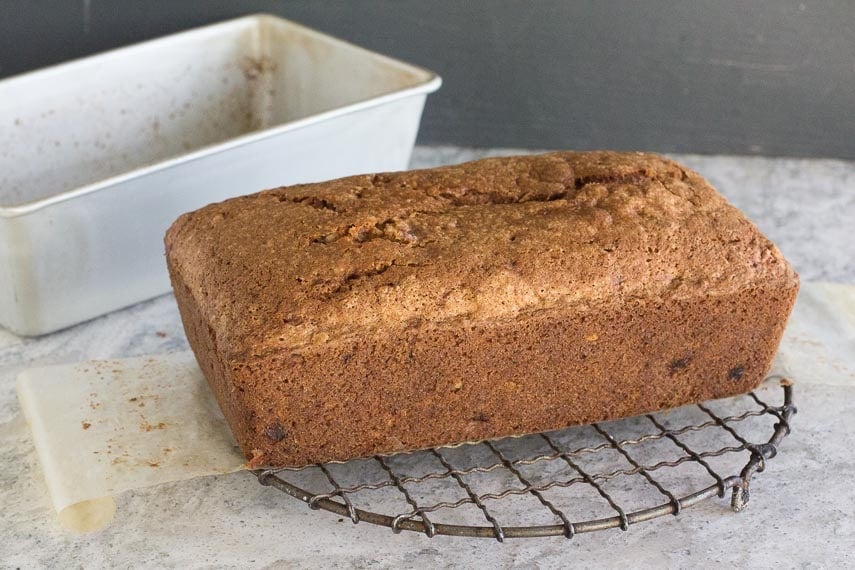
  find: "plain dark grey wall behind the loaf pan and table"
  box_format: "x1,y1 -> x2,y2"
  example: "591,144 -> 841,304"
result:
0,0 -> 855,159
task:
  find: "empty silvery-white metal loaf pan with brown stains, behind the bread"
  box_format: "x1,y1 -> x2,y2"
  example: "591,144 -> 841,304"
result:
0,15 -> 441,335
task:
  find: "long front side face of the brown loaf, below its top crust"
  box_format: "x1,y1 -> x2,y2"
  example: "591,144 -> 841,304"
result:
227,280 -> 796,465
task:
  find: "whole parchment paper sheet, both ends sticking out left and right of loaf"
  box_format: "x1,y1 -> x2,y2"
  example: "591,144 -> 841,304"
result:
18,283 -> 855,532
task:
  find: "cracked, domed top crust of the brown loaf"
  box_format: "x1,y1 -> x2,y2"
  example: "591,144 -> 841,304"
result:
166,152 -> 797,359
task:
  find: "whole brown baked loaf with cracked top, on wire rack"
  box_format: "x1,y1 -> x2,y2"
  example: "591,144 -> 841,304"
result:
166,152 -> 798,467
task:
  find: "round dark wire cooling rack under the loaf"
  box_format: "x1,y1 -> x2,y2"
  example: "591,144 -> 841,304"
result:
254,378 -> 796,542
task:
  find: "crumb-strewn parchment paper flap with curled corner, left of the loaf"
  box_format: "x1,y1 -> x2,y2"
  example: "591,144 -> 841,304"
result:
18,352 -> 245,532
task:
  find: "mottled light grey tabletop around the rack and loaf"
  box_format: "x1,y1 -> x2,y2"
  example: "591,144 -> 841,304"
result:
0,147 -> 855,568
